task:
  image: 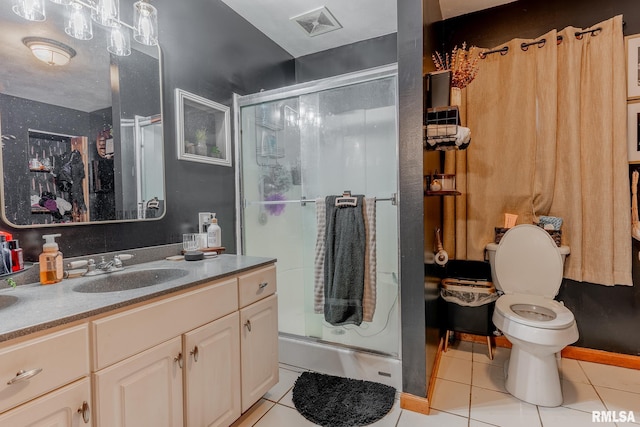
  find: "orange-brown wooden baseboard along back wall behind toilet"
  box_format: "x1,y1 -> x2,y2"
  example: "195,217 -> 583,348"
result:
456,333 -> 640,370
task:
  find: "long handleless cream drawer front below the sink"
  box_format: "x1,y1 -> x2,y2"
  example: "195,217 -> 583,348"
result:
91,278 -> 238,371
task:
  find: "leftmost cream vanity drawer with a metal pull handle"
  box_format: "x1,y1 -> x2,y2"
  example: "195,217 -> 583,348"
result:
0,324 -> 89,412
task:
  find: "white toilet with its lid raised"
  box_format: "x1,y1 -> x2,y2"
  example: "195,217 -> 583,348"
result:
486,225 -> 578,406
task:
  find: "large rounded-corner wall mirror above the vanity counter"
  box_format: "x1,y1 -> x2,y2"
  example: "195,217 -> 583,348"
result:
0,0 -> 165,228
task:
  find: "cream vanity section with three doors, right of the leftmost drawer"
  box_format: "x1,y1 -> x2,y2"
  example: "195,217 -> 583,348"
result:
91,265 -> 278,427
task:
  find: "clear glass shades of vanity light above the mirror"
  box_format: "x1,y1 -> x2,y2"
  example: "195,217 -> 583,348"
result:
12,0 -> 158,56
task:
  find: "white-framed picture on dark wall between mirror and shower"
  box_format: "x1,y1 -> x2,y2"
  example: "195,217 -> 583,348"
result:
175,89 -> 231,166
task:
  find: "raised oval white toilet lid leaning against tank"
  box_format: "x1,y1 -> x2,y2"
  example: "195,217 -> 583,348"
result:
495,224 -> 563,298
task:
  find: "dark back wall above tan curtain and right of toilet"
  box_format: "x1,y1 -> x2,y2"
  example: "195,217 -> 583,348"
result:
438,0 -> 640,355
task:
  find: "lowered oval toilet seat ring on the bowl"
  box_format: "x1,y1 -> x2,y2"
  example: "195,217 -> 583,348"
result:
495,294 -> 575,329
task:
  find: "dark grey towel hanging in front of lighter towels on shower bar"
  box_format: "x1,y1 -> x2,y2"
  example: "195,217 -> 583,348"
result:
324,195 -> 366,326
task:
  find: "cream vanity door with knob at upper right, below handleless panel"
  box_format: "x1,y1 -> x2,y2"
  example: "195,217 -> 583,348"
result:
93,337 -> 183,427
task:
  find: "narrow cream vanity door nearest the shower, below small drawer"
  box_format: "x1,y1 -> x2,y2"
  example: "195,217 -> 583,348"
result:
240,295 -> 278,412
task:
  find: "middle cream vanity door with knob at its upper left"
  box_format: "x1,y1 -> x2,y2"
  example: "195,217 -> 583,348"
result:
184,312 -> 241,427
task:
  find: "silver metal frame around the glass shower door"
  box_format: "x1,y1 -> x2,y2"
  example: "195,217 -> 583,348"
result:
233,63 -> 400,254
